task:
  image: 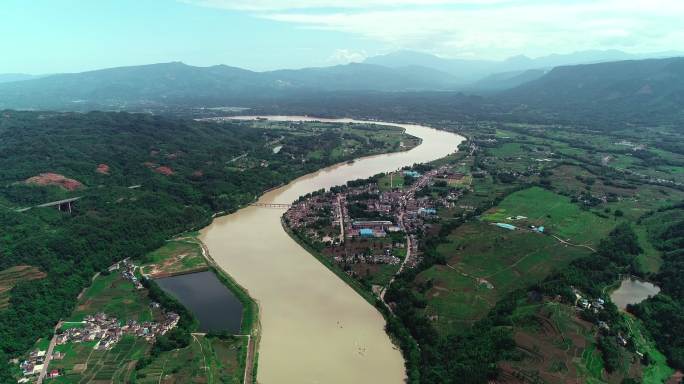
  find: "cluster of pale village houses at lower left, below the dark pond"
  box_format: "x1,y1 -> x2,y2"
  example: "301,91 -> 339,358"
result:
56,312 -> 180,350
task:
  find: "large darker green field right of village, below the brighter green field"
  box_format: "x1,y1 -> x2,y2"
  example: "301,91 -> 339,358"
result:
418,222 -> 590,332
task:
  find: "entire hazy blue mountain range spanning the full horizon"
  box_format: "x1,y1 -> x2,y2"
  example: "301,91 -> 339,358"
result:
0,51 -> 684,118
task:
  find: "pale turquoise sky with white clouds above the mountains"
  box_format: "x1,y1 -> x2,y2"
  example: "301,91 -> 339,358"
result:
0,0 -> 684,74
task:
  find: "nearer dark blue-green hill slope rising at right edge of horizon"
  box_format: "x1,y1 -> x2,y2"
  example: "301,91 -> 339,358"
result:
499,58 -> 684,117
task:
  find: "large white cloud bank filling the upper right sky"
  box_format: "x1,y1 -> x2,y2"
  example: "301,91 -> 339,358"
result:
180,0 -> 684,58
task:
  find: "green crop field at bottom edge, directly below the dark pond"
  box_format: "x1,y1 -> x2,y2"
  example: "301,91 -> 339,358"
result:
136,335 -> 246,384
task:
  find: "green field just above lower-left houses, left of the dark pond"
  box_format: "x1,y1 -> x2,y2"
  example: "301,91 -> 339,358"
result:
67,273 -> 159,321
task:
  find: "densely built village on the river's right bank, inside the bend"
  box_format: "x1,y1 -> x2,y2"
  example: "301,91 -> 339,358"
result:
284,166 -> 464,284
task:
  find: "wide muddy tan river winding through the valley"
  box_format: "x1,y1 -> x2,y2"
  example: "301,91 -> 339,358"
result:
201,116 -> 464,384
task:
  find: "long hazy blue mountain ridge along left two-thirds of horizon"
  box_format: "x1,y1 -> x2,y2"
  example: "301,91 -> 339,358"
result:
0,62 -> 454,108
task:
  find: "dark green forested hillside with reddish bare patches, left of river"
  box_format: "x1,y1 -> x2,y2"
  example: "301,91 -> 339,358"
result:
0,111 -> 406,383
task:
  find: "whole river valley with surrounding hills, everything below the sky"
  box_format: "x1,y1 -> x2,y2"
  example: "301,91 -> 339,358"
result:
0,52 -> 684,383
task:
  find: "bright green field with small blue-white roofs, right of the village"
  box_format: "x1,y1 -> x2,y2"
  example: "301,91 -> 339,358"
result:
483,187 -> 615,245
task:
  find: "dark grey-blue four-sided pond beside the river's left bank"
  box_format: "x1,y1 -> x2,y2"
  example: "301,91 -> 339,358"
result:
155,271 -> 242,334
